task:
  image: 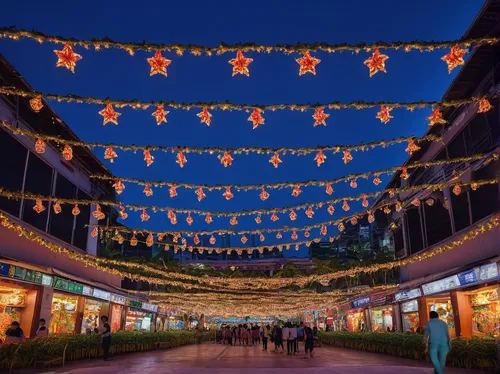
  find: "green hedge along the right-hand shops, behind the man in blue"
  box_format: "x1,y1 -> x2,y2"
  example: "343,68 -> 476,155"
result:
319,331 -> 497,370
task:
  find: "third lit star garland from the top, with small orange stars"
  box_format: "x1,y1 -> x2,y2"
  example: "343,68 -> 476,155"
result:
0,121 -> 442,168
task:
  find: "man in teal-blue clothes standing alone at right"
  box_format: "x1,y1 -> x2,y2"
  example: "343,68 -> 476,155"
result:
424,312 -> 450,374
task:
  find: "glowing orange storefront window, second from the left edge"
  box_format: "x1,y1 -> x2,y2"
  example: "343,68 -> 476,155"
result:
49,292 -> 78,334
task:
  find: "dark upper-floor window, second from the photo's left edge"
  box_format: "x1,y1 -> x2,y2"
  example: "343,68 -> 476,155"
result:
22,152 -> 53,231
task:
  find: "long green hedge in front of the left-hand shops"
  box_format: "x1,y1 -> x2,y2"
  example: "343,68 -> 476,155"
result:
0,330 -> 213,369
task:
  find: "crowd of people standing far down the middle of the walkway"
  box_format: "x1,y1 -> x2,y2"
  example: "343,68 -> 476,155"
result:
216,322 -> 318,358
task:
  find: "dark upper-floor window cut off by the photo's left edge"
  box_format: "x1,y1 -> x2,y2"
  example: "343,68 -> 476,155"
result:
0,130 -> 28,217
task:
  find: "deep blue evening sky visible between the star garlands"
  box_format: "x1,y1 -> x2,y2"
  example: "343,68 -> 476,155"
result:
0,0 -> 483,255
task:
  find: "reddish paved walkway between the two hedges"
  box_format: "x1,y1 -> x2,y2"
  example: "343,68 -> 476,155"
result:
34,343 -> 483,374
